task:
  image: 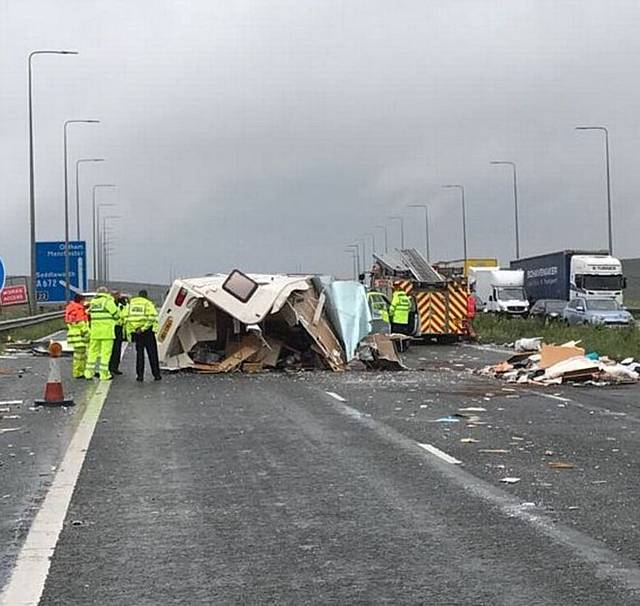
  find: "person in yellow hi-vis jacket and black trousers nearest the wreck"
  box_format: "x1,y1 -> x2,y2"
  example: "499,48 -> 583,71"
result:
125,290 -> 162,381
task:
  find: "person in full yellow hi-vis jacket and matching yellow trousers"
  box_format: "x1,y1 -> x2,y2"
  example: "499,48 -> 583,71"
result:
84,286 -> 120,381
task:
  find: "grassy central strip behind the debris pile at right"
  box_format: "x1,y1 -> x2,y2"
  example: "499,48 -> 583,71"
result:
473,314 -> 640,360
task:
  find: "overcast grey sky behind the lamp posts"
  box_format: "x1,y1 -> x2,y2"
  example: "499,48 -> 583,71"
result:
0,0 -> 640,281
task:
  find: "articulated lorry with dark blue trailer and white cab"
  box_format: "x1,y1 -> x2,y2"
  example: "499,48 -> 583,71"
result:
510,250 -> 627,304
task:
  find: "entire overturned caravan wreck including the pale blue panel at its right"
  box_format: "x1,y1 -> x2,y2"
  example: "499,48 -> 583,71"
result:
157,270 -> 403,374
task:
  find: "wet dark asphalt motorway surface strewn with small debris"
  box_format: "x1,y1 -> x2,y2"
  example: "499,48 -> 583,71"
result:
0,346 -> 640,606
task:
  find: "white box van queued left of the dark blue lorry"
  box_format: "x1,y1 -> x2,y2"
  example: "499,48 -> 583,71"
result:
469,267 -> 529,316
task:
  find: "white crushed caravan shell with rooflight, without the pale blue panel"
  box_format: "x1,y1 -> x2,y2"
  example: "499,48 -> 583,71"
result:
158,271 -> 346,373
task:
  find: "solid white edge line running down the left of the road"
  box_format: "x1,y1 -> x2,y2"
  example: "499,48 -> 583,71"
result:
0,381 -> 111,606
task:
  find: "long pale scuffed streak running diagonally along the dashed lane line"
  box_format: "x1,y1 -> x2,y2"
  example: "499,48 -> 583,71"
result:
324,394 -> 640,591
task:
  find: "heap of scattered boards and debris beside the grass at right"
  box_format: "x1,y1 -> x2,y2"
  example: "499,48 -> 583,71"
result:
478,339 -> 640,387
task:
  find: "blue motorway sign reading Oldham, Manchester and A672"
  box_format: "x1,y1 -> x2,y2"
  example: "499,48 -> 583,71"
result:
36,241 -> 87,303
